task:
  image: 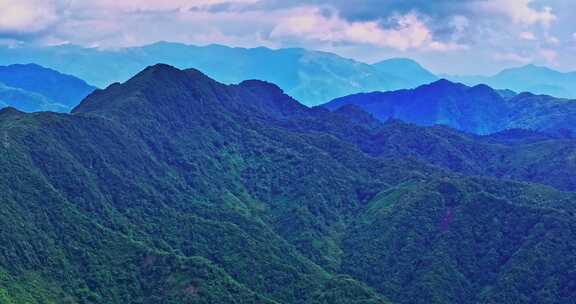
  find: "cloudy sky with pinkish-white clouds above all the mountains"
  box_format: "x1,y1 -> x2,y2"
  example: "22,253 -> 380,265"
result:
0,0 -> 576,74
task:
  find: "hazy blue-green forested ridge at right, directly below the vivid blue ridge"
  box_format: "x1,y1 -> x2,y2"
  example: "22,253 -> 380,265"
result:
360,121 -> 576,191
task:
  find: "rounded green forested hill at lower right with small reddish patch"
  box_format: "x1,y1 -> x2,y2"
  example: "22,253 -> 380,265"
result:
343,179 -> 575,303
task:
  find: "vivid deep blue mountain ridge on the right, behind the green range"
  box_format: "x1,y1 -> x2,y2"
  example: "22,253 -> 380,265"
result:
323,79 -> 576,134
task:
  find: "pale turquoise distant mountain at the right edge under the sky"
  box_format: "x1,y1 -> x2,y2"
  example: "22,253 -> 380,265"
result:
445,64 -> 576,98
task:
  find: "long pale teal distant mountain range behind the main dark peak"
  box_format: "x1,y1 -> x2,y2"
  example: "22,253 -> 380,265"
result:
0,42 -> 434,105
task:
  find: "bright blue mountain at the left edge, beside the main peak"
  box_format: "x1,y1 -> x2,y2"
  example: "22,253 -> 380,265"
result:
0,64 -> 95,112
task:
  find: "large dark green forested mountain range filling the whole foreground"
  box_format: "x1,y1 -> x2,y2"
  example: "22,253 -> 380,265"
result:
0,65 -> 576,304
